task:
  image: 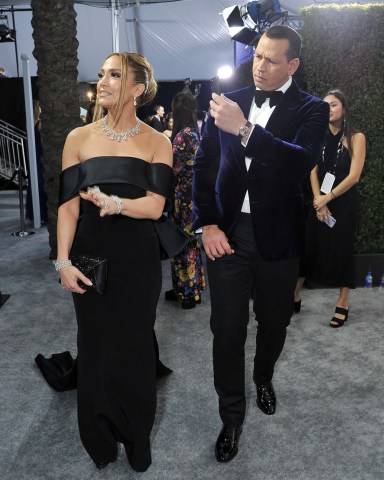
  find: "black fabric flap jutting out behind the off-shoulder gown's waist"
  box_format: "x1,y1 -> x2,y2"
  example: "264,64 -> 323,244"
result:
153,215 -> 193,260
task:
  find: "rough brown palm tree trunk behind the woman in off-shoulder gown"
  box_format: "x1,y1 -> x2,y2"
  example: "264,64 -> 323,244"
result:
31,0 -> 81,259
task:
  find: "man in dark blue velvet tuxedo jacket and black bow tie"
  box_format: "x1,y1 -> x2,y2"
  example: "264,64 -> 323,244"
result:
193,26 -> 329,462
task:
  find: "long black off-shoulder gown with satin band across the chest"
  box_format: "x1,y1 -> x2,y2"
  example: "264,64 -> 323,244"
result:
60,157 -> 173,471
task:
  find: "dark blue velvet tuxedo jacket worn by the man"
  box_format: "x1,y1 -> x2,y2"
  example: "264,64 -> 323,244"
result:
193,82 -> 329,261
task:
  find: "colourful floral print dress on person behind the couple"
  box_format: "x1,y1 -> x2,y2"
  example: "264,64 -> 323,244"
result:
171,127 -> 206,301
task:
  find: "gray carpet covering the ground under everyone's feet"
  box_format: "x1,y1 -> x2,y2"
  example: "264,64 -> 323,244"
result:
0,191 -> 384,480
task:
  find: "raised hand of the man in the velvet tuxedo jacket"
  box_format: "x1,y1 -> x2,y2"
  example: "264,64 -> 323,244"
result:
209,93 -> 247,135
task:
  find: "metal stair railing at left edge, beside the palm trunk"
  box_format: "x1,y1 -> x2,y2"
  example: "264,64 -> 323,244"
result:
0,120 -> 28,185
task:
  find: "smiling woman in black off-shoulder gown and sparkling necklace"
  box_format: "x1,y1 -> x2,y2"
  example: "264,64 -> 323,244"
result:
55,53 -> 173,471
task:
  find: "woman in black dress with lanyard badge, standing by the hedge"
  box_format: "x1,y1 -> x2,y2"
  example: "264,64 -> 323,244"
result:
295,90 -> 366,328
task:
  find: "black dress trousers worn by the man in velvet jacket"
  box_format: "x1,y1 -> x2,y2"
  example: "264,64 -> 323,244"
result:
207,213 -> 299,426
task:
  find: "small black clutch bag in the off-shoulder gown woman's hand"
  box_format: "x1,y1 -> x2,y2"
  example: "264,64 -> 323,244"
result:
70,255 -> 108,295
